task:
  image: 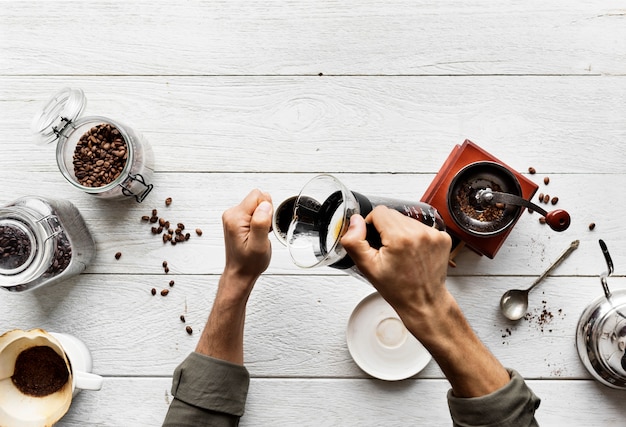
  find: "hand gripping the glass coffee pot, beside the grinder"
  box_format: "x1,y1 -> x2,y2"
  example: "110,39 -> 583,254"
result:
341,206 -> 452,338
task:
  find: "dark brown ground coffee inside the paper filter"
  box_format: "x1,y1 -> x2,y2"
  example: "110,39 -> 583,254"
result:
11,346 -> 69,397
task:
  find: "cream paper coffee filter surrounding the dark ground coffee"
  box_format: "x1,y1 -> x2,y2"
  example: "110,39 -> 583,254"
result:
0,329 -> 72,427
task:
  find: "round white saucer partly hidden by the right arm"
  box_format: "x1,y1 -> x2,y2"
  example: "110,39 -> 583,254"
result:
346,292 -> 432,381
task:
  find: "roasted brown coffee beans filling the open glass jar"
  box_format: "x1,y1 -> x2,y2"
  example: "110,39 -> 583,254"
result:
73,123 -> 128,187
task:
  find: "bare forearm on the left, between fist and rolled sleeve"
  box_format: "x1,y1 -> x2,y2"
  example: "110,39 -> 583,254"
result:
196,271 -> 256,365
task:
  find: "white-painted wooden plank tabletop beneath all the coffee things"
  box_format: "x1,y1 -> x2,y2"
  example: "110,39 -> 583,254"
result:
0,0 -> 626,426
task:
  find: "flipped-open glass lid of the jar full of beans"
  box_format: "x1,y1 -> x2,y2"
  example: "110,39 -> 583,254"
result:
31,87 -> 87,144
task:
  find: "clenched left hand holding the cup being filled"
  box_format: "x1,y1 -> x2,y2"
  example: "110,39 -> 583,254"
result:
222,190 -> 273,286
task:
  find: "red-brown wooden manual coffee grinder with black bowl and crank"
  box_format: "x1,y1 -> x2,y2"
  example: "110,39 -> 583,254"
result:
421,140 -> 570,266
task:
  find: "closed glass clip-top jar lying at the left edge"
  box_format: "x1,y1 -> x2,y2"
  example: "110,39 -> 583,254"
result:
0,196 -> 96,292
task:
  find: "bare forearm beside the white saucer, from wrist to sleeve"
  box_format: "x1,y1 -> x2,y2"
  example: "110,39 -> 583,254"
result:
406,293 -> 510,397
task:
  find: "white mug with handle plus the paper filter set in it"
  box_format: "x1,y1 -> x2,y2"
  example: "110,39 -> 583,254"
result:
0,329 -> 102,427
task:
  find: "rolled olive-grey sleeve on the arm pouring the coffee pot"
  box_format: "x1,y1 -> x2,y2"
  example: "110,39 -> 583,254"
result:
448,370 -> 541,427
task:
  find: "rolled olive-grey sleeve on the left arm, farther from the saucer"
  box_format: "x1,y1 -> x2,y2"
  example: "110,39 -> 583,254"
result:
163,352 -> 250,427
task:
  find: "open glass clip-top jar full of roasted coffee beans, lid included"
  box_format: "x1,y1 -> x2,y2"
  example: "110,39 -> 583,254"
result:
31,88 -> 154,202
